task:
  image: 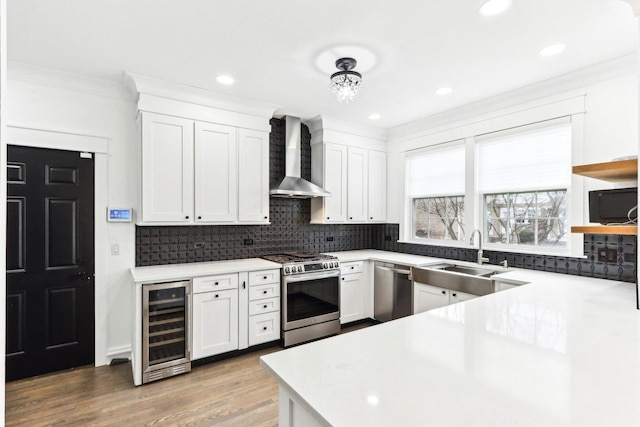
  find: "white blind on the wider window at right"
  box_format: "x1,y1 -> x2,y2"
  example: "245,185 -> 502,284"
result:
476,118 -> 571,194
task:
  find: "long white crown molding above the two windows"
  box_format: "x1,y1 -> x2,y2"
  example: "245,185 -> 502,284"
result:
388,53 -> 640,141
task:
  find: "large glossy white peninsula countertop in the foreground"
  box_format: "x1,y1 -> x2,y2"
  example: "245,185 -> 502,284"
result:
261,268 -> 640,427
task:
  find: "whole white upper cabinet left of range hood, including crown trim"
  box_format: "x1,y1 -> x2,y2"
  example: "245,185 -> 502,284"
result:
125,73 -> 276,225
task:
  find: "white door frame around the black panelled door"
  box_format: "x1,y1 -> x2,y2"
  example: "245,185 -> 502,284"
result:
2,125 -> 110,366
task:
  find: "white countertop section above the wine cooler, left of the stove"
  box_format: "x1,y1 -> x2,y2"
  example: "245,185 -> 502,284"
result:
131,258 -> 280,283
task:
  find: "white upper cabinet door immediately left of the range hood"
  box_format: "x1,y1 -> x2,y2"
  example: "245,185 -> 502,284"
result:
238,129 -> 269,223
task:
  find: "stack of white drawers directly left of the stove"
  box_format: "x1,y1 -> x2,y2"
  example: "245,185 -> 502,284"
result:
248,269 -> 280,346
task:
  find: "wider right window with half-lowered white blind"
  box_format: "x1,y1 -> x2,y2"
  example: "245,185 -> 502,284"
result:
476,119 -> 571,248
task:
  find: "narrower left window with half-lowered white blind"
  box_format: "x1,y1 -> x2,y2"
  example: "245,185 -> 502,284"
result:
407,141 -> 465,240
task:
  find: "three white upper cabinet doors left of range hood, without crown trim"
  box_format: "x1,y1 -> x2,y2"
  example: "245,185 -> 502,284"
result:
139,112 -> 269,225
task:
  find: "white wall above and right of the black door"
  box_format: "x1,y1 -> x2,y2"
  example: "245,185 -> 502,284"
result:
4,64 -> 138,365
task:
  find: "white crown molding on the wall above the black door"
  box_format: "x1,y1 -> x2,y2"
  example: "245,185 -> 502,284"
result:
7,61 -> 134,101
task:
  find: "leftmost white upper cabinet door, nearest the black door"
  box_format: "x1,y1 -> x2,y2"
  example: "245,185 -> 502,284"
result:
141,113 -> 193,222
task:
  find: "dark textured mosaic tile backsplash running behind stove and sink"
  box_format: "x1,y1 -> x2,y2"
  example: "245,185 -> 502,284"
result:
136,119 -> 637,283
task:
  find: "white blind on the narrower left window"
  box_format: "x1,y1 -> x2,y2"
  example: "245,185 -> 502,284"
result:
407,142 -> 465,197
